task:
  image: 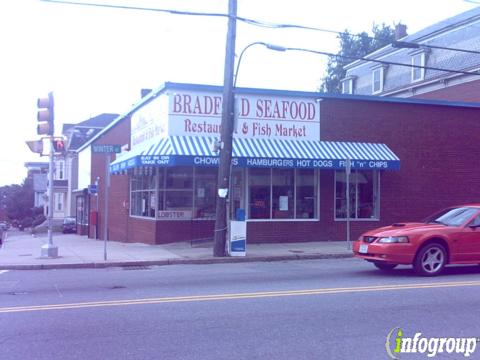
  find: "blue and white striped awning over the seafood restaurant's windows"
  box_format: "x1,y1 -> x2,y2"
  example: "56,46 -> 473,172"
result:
110,136 -> 400,173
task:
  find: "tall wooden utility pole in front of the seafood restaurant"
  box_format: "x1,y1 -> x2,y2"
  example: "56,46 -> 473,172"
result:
213,0 -> 237,257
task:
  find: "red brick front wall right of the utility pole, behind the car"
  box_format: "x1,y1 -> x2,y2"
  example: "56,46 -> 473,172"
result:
248,99 -> 480,243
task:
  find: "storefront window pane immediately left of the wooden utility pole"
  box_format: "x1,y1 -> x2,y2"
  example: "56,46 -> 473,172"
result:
194,167 -> 217,219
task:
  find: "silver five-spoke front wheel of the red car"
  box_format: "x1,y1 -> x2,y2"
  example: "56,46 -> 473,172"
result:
413,243 -> 447,276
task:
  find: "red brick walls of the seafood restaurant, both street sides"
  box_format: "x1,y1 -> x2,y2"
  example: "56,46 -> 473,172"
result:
91,98 -> 480,244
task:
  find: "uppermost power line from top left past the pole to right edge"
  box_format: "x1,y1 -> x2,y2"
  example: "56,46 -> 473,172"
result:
40,0 -> 480,55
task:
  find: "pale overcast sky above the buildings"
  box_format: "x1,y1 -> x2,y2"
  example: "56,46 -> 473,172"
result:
0,0 -> 477,186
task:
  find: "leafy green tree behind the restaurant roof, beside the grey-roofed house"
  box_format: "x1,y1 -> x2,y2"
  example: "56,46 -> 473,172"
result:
320,24 -> 395,94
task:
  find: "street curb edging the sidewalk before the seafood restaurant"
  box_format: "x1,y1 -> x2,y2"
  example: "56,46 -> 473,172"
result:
0,254 -> 353,270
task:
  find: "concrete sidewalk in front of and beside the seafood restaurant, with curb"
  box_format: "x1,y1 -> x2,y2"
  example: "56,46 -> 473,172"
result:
0,231 -> 352,270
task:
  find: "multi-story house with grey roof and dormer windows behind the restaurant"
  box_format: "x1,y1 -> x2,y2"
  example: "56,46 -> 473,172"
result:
342,7 -> 480,101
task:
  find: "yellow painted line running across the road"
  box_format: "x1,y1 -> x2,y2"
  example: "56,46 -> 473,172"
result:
0,281 -> 480,313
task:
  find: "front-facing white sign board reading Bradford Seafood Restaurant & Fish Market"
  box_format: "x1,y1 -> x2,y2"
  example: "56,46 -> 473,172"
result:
168,91 -> 320,140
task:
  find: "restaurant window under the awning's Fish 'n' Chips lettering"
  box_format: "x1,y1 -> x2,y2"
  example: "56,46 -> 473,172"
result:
335,170 -> 379,220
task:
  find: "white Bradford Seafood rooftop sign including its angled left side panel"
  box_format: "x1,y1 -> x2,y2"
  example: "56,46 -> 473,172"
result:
131,90 -> 320,147
